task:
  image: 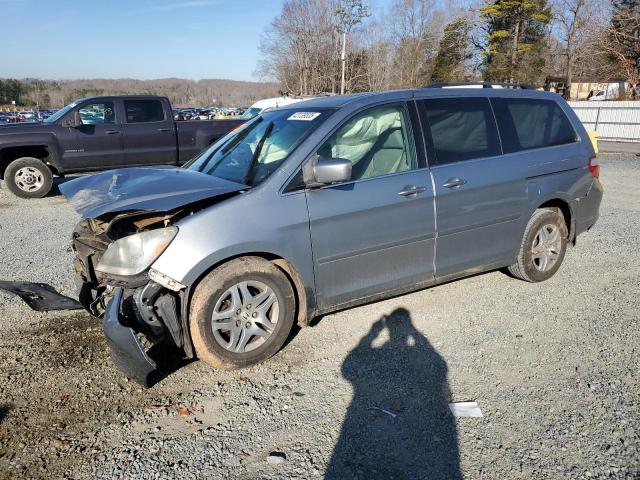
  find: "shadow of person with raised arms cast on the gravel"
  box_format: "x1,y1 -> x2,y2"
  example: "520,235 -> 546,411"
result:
325,308 -> 462,480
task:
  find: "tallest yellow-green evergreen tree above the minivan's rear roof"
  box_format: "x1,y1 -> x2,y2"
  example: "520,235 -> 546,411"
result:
481,0 -> 551,83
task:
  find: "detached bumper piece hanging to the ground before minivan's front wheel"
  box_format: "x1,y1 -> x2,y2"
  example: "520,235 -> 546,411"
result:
104,288 -> 156,387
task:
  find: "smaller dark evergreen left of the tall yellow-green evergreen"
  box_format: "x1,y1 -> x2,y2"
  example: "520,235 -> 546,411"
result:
431,18 -> 471,82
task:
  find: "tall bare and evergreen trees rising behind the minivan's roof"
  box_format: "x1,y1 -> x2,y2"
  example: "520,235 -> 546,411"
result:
258,0 -> 640,95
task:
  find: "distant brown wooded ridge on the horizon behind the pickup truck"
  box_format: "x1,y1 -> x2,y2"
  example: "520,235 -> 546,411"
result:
0,78 -> 279,108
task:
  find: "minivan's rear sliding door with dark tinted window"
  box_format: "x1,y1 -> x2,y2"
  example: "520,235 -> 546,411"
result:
419,98 -> 527,280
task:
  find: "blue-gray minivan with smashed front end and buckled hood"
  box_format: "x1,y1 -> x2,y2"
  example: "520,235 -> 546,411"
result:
60,88 -> 603,384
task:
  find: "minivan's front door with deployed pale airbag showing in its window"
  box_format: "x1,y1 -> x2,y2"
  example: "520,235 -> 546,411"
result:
306,103 -> 435,308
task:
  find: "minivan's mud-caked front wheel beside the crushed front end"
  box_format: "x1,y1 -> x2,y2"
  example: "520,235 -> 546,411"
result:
189,257 -> 296,369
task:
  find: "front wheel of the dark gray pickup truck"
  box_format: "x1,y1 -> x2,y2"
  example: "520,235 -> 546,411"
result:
4,157 -> 53,198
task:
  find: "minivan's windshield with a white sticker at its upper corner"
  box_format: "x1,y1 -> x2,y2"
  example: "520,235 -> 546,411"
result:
185,109 -> 331,185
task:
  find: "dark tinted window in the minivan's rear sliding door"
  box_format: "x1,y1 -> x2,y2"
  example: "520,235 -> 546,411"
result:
422,98 -> 500,165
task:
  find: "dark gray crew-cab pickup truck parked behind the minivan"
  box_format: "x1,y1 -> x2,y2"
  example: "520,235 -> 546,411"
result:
0,96 -> 243,198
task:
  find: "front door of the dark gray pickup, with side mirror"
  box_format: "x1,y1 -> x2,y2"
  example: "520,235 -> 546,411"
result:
61,100 -> 124,172
